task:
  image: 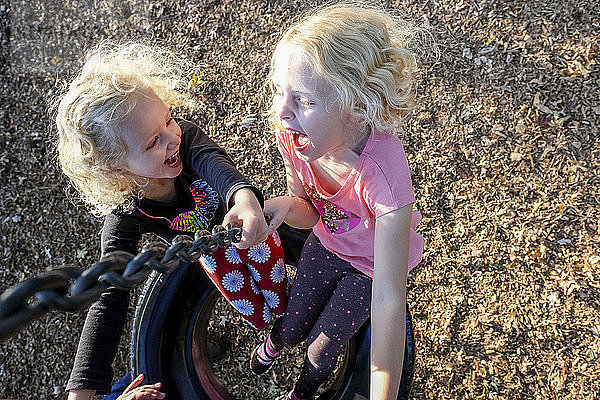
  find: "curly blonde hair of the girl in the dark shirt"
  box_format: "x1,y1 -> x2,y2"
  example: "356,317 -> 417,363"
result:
52,42 -> 192,215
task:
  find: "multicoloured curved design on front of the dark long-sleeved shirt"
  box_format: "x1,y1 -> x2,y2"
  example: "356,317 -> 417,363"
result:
136,179 -> 219,233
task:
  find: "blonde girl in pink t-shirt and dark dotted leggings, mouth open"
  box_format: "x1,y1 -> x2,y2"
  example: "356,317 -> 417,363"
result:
250,2 -> 424,400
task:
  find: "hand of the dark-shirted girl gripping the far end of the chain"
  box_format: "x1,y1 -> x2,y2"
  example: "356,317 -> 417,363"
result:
223,188 -> 267,249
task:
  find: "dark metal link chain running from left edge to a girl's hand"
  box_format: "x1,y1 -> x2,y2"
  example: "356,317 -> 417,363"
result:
0,225 -> 242,341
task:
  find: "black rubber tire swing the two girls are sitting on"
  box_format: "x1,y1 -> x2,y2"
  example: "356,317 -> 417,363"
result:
130,226 -> 415,400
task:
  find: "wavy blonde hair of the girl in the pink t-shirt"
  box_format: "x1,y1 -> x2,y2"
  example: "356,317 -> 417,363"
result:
269,1 -> 420,133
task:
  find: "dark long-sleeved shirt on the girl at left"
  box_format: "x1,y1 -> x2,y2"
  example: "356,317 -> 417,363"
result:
67,120 -> 264,394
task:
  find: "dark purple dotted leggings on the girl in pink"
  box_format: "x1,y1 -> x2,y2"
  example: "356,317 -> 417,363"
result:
271,233 -> 372,398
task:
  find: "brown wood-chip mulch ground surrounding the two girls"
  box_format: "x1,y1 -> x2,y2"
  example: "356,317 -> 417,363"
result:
0,0 -> 600,399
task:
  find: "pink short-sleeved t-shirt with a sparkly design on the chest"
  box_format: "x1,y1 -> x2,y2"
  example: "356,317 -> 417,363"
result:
277,130 -> 424,277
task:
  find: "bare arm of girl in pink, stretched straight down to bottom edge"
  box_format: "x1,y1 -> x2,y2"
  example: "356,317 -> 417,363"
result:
370,205 -> 412,400
